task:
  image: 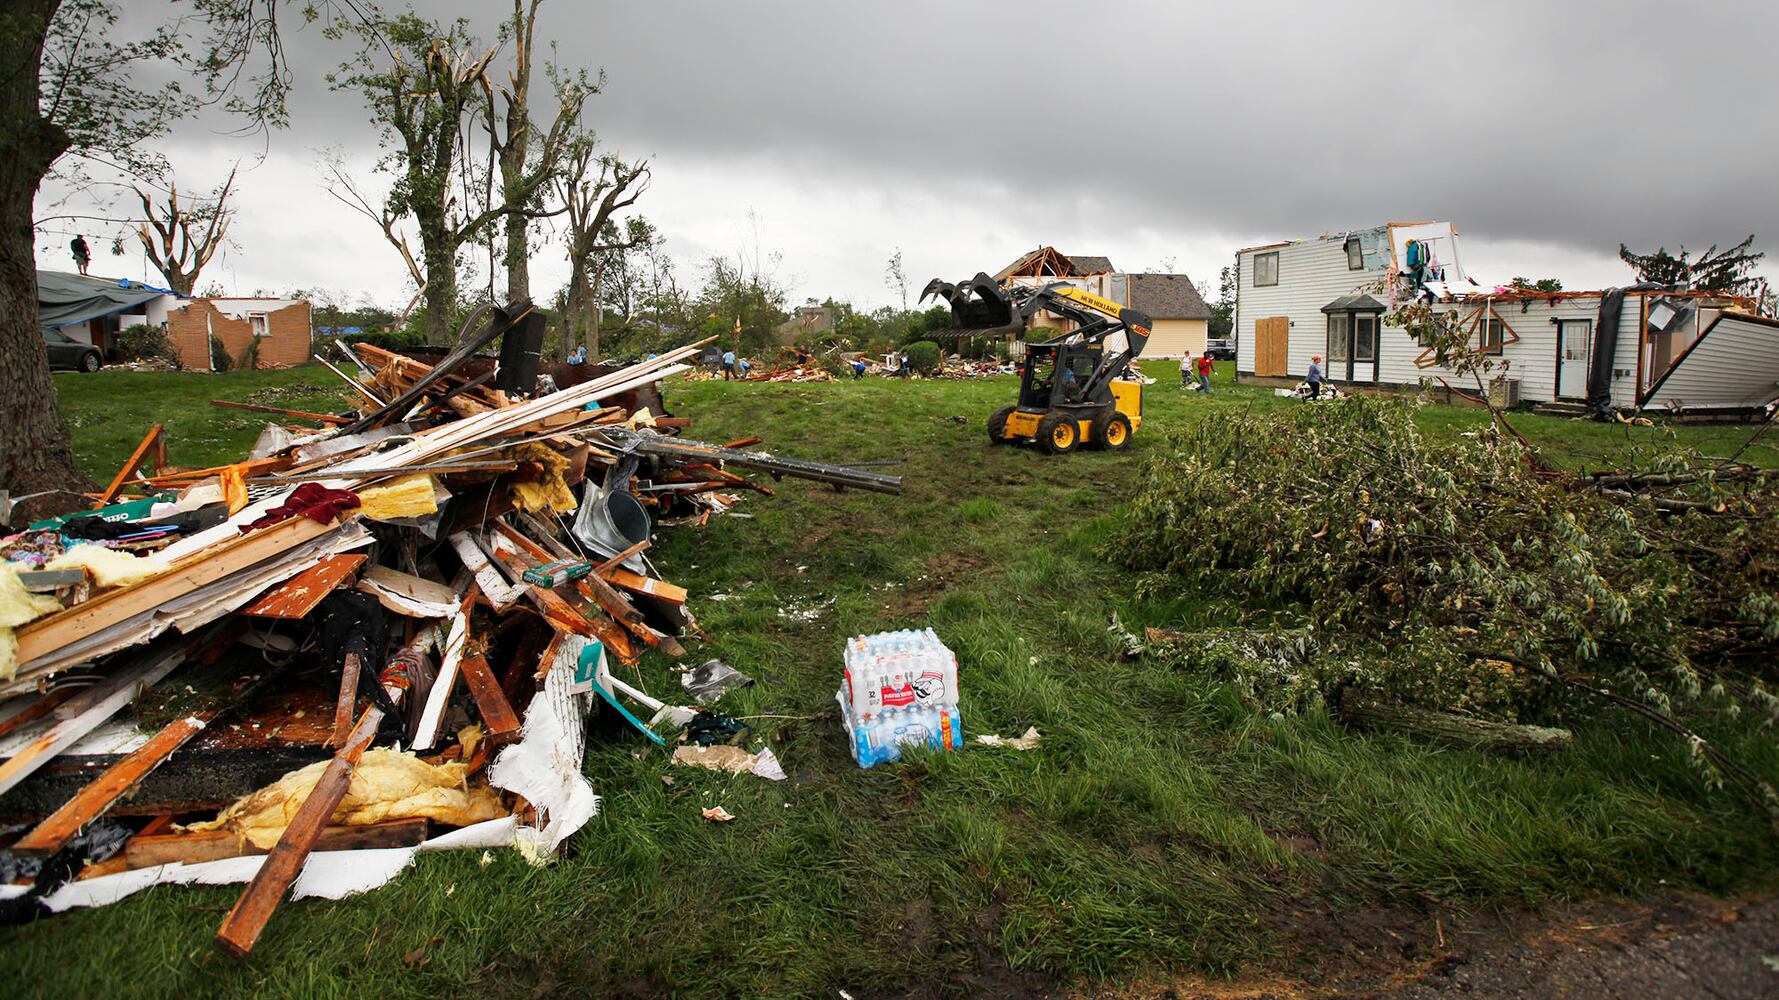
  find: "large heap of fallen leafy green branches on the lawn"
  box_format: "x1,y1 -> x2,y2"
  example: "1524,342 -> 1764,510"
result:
1115,389 -> 1779,817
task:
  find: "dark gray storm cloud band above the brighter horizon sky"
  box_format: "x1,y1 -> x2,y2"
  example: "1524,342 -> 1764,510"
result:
551,2 -> 1779,249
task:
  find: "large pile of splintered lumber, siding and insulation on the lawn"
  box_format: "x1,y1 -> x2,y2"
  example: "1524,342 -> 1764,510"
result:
0,302 -> 900,956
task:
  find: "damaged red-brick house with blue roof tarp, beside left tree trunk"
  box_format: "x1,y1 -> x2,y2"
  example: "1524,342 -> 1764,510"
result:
37,270 -> 311,370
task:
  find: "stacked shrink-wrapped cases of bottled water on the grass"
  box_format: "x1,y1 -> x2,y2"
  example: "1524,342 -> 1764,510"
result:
834,628 -> 964,767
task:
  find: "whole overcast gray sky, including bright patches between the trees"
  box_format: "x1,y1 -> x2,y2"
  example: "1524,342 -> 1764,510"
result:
37,0 -> 1779,306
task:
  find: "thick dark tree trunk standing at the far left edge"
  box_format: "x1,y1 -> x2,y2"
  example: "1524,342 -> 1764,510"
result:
0,0 -> 93,512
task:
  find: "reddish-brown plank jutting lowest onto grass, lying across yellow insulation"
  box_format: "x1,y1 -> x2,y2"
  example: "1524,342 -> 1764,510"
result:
215,705 -> 382,959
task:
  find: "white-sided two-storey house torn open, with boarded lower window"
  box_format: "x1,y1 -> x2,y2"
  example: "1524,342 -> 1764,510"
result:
1235,222 -> 1779,415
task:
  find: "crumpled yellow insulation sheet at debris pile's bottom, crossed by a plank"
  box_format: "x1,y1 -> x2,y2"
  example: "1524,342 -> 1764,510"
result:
185,749 -> 507,849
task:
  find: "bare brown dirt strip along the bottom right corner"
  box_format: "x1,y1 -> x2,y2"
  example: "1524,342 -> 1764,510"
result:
1087,895 -> 1779,1000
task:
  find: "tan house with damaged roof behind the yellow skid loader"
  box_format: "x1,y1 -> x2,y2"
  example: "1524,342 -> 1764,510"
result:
994,247 -> 1211,358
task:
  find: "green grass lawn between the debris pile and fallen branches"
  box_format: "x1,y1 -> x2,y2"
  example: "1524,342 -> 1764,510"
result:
13,363 -> 1779,996
